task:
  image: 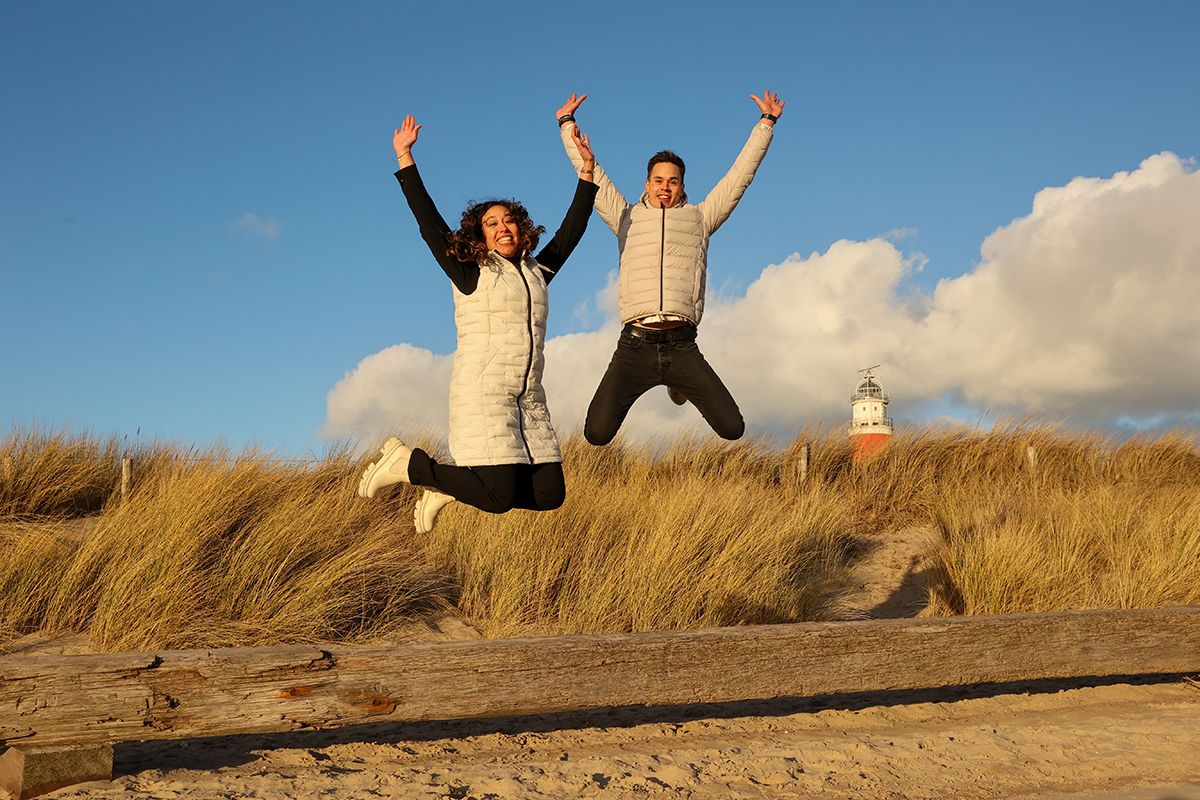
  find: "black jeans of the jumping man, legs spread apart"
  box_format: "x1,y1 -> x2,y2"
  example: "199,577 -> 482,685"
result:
583,325 -> 746,445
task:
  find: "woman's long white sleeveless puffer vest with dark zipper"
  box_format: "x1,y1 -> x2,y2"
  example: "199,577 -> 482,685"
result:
450,253 -> 563,467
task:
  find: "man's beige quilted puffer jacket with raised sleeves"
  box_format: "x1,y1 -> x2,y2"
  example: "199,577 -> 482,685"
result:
562,122 -> 773,324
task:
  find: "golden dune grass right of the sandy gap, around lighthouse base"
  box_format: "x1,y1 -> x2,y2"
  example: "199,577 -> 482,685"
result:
814,425 -> 1200,614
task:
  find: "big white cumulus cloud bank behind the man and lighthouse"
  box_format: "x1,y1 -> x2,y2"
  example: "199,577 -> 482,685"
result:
325,152 -> 1200,444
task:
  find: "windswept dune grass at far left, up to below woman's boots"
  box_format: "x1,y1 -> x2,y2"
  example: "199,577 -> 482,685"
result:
0,437 -> 451,650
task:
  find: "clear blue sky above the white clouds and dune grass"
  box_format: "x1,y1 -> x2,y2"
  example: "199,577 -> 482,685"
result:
0,1 -> 1200,453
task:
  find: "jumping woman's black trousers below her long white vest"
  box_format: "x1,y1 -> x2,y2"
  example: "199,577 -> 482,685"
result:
408,447 -> 566,513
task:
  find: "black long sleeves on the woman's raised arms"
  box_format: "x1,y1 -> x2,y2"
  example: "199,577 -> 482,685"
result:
396,164 -> 596,294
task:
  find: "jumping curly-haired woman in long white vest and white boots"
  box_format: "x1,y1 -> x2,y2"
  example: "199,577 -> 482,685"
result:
359,114 -> 596,534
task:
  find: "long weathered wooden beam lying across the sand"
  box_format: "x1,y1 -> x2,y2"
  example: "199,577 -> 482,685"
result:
0,607 -> 1200,745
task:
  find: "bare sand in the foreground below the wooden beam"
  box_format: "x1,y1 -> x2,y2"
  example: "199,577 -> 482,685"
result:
25,682 -> 1200,800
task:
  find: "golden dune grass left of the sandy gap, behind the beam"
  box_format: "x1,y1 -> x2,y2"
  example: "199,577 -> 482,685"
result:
0,433 -> 850,650
